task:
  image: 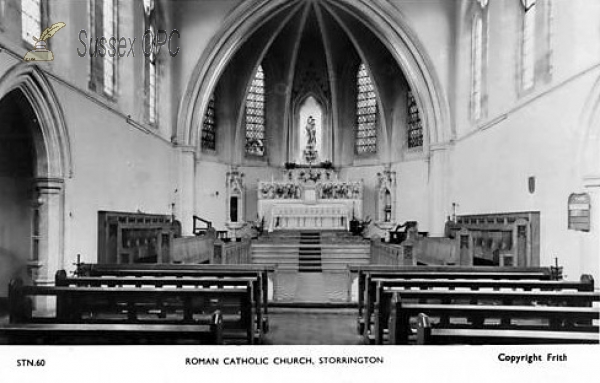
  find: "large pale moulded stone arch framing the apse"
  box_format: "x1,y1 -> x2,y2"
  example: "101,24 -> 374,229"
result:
177,0 -> 452,153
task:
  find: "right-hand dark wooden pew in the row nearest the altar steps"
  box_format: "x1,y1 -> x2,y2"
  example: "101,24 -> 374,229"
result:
348,265 -> 551,334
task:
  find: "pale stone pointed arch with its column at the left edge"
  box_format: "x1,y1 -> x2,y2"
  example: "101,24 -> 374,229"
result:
0,63 -> 73,285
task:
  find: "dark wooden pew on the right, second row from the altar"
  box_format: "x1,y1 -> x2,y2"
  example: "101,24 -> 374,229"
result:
364,276 -> 599,344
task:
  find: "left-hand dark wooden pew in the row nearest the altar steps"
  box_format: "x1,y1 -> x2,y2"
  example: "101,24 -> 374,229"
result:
76,264 -> 275,333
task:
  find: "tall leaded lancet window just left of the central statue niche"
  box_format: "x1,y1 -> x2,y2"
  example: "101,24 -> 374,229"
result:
246,65 -> 266,157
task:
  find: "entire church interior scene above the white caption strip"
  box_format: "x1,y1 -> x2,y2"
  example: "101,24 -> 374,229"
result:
0,0 -> 600,345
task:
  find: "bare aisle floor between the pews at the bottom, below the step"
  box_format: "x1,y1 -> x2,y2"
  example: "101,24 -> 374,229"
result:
265,309 -> 362,345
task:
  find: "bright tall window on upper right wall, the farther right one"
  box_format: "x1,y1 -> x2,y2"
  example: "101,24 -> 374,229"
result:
521,0 -> 537,90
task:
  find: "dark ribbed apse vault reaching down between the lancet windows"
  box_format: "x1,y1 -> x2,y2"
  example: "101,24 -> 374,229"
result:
211,0 -> 408,163
